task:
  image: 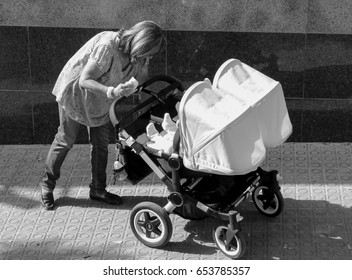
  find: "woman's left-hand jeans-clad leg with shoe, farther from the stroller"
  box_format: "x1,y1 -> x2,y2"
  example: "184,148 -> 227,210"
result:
40,105 -> 80,209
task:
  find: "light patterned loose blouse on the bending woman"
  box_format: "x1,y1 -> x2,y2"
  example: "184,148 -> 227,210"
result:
53,31 -> 135,127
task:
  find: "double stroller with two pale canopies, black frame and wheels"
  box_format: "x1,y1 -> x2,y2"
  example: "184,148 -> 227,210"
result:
109,59 -> 292,259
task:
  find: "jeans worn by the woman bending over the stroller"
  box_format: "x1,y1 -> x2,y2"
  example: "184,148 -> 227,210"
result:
40,105 -> 111,192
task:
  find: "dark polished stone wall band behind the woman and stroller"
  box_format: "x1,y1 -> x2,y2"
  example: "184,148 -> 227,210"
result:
0,26 -> 352,144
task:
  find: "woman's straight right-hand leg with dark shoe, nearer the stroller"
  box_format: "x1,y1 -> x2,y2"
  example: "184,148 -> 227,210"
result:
88,123 -> 121,204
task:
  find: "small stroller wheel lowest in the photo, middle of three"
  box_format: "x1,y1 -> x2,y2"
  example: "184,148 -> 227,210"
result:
213,225 -> 246,259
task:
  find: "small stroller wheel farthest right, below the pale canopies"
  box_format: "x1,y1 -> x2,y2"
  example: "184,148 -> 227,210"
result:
252,186 -> 284,217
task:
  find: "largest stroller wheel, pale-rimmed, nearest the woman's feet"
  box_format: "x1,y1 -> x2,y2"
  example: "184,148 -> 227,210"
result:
130,202 -> 172,248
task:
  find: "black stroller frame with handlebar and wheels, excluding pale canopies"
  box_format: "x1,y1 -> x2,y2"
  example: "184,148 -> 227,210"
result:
110,75 -> 284,259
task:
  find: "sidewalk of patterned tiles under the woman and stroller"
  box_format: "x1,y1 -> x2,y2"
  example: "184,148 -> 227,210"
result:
0,143 -> 352,260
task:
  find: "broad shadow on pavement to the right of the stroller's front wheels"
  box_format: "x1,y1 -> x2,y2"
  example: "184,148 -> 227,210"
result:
236,198 -> 352,260
